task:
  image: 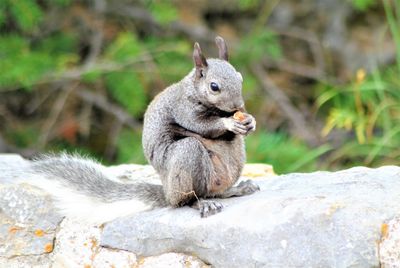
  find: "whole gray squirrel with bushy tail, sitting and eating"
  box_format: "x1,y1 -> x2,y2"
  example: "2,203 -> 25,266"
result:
0,37 -> 259,222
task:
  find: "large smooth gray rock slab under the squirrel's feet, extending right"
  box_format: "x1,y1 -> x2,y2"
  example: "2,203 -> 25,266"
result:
101,166 -> 400,267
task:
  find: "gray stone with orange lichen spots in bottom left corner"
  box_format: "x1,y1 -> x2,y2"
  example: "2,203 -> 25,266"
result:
0,185 -> 62,257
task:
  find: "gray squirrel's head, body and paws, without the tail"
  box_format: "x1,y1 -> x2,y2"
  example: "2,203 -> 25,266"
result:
142,38 -> 257,216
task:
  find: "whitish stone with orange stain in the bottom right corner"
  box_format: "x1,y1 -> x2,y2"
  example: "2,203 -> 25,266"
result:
379,216 -> 400,268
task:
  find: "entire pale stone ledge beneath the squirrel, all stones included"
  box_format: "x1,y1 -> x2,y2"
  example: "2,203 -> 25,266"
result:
0,156 -> 400,267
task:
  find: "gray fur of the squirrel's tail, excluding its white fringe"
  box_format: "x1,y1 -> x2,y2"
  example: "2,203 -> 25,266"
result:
28,154 -> 166,207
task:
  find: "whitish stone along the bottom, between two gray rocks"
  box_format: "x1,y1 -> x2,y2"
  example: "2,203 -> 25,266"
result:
52,219 -> 207,268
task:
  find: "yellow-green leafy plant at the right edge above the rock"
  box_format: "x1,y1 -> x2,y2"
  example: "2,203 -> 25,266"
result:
317,0 -> 400,166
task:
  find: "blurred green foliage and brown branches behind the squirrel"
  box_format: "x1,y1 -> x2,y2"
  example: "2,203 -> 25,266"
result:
0,0 -> 400,173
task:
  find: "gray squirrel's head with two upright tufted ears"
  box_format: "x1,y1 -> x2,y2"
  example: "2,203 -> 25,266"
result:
193,36 -> 244,112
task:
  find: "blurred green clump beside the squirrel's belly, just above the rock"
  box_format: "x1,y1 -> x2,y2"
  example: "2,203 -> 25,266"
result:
246,132 -> 330,174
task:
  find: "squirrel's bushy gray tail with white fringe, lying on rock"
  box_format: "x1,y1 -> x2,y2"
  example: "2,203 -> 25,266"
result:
0,154 -> 166,223
